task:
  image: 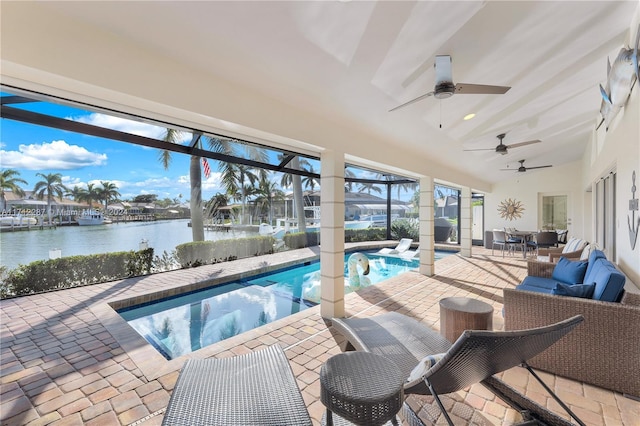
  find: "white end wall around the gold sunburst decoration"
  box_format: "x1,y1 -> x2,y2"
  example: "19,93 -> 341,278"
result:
485,161 -> 586,238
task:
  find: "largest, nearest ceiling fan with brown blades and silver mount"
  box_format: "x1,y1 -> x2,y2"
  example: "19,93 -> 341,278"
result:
389,55 -> 511,112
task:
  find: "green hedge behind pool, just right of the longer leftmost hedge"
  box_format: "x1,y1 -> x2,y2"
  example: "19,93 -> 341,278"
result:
176,236 -> 276,268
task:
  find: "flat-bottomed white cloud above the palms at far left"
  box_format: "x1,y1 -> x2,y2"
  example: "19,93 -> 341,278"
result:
0,140 -> 107,170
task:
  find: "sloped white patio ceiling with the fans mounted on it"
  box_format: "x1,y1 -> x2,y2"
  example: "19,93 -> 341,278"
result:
37,0 -> 638,182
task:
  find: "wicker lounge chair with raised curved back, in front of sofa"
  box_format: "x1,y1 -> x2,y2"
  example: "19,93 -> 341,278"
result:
332,312 -> 583,425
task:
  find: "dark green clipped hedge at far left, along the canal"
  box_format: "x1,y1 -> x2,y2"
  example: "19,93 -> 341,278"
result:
0,248 -> 153,298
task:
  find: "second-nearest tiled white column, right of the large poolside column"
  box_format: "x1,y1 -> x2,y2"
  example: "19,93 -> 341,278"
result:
419,176 -> 435,276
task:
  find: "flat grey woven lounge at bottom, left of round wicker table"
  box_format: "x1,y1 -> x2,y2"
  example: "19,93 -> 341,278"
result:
162,344 -> 312,426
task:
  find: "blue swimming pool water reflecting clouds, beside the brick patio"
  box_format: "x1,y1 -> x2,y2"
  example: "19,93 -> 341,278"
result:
118,252 -> 448,359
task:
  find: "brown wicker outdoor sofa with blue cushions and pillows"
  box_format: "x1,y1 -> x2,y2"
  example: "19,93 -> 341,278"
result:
503,250 -> 640,397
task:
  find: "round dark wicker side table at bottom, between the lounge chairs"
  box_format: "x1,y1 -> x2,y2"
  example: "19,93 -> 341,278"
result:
320,352 -> 406,426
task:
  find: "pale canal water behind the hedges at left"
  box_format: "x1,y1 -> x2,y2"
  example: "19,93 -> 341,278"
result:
0,219 -> 258,269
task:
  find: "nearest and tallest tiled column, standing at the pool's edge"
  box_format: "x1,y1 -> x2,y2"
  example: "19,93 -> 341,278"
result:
320,151 -> 345,318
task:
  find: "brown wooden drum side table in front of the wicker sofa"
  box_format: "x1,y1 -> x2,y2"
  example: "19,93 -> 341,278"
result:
440,297 -> 493,343
